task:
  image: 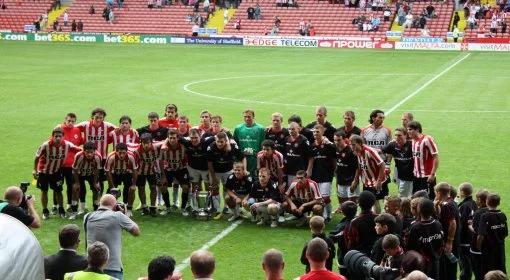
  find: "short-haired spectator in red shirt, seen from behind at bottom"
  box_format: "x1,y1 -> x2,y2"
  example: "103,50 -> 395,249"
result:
299,237 -> 346,280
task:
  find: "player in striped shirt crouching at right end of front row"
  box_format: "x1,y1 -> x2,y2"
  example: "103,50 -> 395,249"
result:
283,170 -> 322,227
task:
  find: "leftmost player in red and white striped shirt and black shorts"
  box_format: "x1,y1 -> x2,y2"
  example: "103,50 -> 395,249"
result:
33,127 -> 81,219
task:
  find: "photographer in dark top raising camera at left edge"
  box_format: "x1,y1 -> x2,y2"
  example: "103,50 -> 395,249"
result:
0,186 -> 41,228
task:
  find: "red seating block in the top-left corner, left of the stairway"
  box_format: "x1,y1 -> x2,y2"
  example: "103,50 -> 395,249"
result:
0,0 -> 53,32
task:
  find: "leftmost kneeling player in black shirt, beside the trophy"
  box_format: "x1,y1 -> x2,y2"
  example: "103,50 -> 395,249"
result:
225,162 -> 253,222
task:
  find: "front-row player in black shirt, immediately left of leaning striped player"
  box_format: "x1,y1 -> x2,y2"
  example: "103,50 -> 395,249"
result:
334,130 -> 360,208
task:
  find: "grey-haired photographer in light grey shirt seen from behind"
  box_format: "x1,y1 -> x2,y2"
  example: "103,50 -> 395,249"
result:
83,194 -> 140,280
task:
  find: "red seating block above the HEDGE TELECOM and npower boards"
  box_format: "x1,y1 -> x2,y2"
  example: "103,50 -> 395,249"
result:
223,0 -> 393,36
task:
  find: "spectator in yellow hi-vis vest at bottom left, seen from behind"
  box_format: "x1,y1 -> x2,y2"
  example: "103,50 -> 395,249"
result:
64,241 -> 111,280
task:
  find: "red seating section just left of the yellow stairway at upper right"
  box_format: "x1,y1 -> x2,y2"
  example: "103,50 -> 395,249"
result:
403,1 -> 455,38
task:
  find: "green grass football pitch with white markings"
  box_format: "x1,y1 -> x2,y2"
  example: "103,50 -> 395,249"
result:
0,41 -> 510,280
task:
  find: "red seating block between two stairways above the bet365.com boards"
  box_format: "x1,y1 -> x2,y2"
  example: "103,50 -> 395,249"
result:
53,0 -> 207,35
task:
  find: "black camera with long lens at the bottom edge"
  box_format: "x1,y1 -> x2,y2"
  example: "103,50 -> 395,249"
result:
344,250 -> 400,280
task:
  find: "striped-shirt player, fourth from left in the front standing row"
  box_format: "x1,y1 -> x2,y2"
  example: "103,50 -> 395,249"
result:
133,133 -> 161,216
